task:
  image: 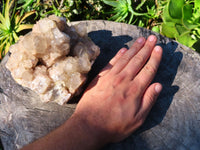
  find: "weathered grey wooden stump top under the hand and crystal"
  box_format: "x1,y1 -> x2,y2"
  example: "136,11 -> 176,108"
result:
0,21 -> 200,150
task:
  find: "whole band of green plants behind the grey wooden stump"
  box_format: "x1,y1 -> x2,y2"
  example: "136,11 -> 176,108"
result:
0,0 -> 200,150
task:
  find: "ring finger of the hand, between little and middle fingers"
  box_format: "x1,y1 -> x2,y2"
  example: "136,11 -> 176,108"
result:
110,37 -> 145,75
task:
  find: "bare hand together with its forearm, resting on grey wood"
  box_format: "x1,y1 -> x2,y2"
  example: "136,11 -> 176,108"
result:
22,35 -> 162,150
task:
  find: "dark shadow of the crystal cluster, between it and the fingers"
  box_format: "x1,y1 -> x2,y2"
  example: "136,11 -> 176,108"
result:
88,30 -> 132,80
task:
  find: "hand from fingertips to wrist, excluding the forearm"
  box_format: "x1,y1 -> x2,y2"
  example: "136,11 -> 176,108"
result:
73,35 -> 162,144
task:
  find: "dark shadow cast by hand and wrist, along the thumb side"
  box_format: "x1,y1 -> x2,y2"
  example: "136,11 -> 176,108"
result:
104,41 -> 183,150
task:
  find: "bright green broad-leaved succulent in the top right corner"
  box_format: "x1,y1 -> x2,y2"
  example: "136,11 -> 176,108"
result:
161,0 -> 200,52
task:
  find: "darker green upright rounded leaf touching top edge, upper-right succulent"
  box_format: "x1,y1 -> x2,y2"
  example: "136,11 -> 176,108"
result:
168,0 -> 185,19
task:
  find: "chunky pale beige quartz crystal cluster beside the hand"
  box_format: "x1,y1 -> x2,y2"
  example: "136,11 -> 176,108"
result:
6,16 -> 100,105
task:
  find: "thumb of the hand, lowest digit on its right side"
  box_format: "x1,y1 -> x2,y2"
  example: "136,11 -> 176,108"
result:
139,83 -> 162,119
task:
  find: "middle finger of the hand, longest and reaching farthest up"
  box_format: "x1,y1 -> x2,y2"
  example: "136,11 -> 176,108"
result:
122,35 -> 157,80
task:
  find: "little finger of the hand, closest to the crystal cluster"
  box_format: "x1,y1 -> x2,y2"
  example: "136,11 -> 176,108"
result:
99,48 -> 127,76
